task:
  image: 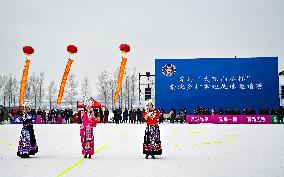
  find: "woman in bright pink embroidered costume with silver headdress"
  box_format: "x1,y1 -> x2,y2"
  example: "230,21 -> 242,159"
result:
80,99 -> 97,158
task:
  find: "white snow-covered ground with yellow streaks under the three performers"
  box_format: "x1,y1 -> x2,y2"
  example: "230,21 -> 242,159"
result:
0,124 -> 284,177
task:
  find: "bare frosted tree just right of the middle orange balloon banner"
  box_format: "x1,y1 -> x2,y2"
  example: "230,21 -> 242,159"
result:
64,74 -> 78,107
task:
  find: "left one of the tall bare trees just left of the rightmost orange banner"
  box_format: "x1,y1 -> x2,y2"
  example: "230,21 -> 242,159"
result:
98,70 -> 110,105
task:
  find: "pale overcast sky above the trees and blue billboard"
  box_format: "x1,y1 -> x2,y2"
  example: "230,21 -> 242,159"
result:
0,0 -> 284,97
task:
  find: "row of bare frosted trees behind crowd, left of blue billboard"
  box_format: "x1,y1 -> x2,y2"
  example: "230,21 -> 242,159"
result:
0,68 -> 138,109
